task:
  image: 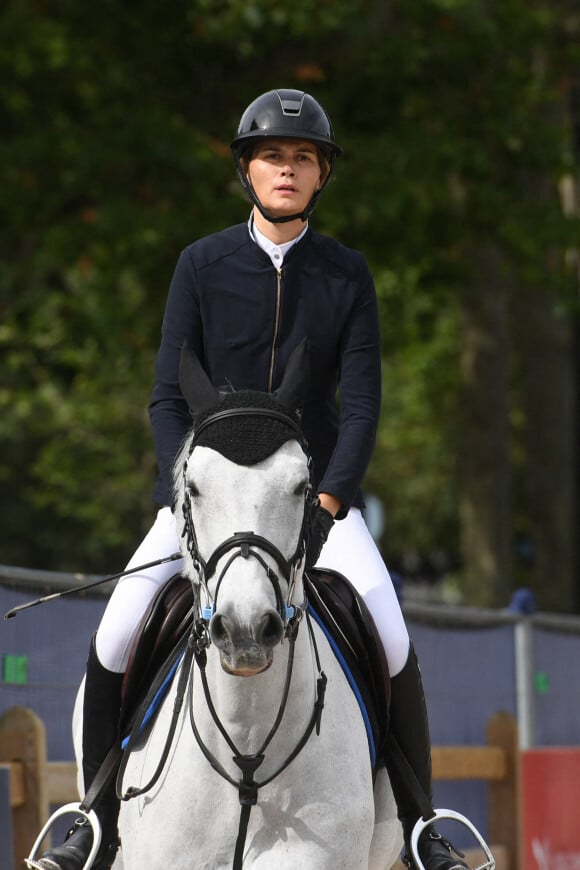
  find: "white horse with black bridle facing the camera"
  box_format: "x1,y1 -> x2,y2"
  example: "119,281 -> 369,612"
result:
76,348 -> 402,870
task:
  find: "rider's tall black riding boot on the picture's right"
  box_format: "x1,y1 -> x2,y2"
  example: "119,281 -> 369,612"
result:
385,645 -> 467,870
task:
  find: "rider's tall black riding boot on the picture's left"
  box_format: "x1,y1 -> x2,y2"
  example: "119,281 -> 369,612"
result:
36,637 -> 123,870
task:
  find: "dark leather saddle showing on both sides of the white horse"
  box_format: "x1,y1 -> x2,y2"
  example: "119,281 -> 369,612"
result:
120,568 -> 390,771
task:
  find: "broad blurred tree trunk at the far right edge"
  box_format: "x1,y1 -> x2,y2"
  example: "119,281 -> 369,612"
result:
514,287 -> 578,612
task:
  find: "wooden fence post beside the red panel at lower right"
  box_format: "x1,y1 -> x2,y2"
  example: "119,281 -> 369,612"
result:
486,711 -> 521,870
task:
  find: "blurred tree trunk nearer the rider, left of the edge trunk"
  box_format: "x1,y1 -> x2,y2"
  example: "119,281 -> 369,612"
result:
458,242 -> 512,607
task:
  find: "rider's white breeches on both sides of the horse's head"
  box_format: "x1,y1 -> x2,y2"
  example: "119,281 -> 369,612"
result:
96,507 -> 409,677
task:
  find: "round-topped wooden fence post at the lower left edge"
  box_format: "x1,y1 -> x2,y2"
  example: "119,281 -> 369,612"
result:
0,707 -> 49,867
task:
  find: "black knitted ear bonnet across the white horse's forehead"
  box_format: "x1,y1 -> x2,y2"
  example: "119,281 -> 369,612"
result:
193,390 -> 300,466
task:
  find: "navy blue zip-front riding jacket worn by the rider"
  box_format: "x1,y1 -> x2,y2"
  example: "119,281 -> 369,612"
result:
149,223 -> 381,516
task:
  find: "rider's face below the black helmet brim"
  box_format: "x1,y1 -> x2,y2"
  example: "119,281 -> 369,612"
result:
248,139 -> 322,217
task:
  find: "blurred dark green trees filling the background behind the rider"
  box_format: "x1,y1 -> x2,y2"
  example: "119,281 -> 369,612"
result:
0,0 -> 580,612
